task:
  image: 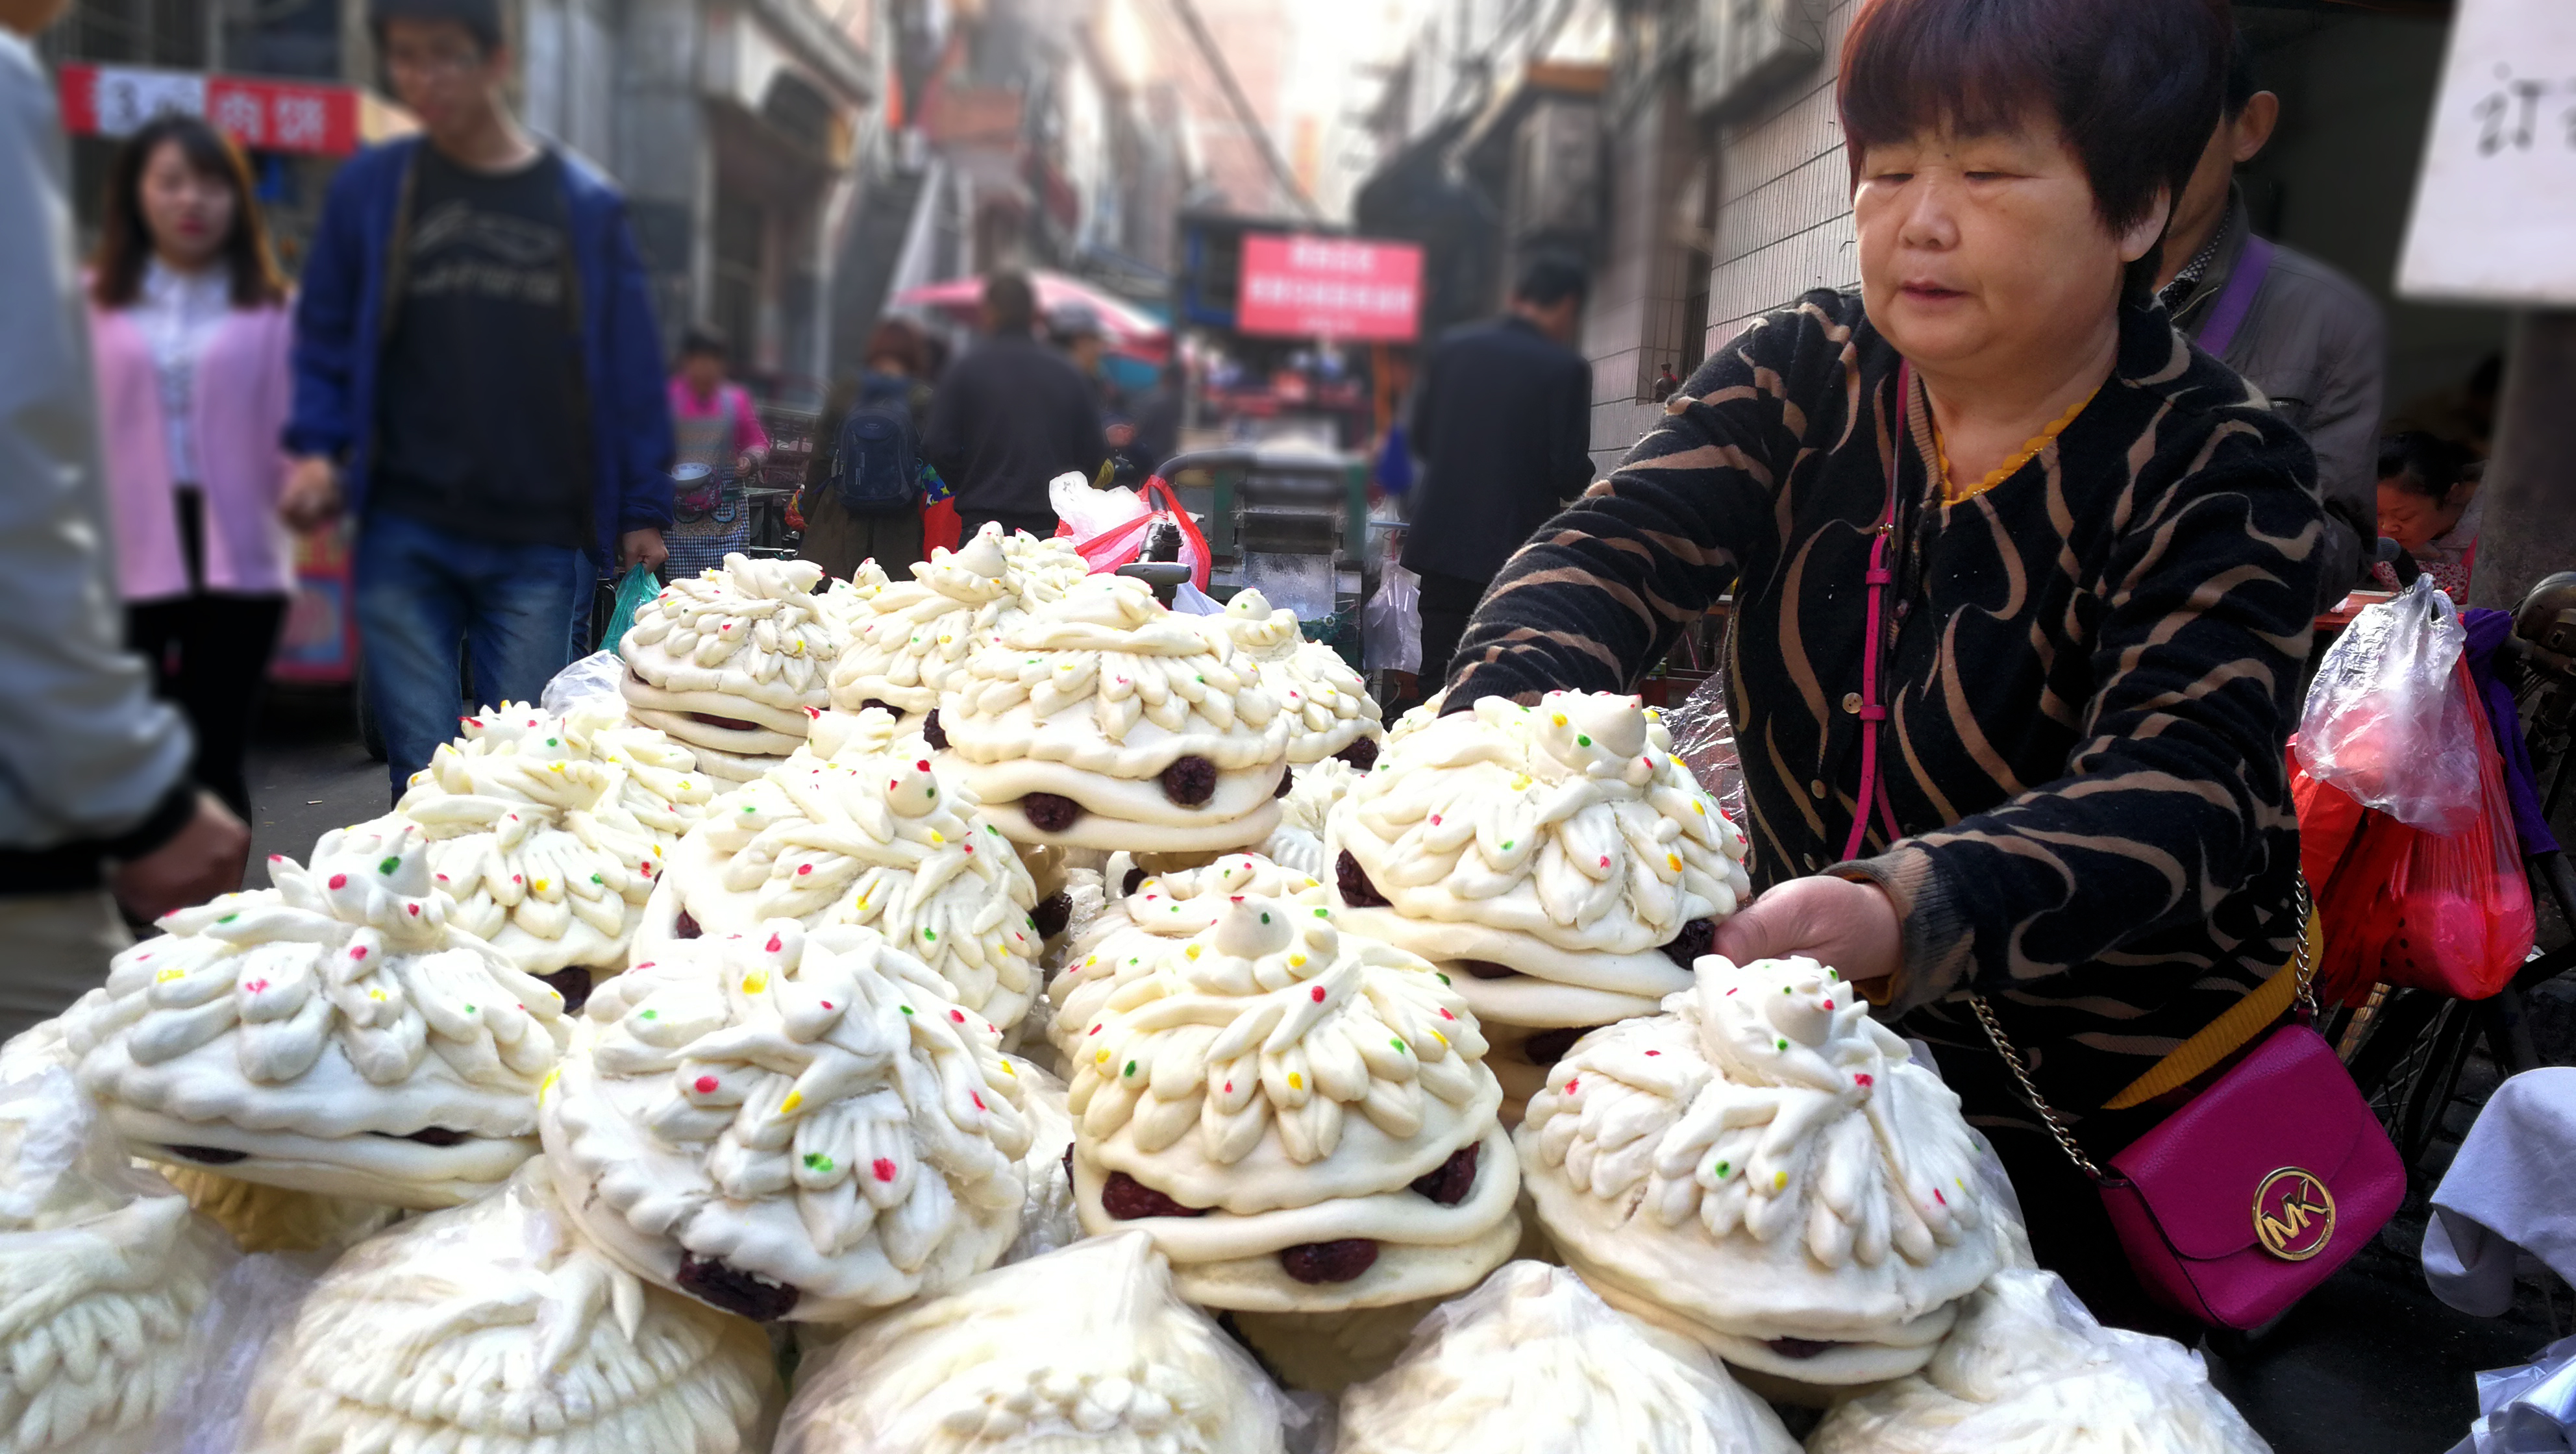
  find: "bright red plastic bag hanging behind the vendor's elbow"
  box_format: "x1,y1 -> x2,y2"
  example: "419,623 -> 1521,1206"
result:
2290,654 -> 2537,1004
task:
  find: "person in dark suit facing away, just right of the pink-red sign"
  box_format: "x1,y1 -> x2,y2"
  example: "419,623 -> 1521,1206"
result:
1404,257 -> 1592,682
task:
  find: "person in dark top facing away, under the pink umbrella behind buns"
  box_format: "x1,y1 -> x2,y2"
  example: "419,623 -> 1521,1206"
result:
923,273 -> 1110,536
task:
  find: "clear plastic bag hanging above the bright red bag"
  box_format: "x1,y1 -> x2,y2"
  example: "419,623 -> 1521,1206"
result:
2297,576 -> 2486,834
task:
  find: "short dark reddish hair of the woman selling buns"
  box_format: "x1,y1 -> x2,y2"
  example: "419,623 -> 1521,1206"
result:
1834,0 -> 2236,254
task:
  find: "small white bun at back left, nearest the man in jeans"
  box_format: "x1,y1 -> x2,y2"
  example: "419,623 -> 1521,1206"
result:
618,556 -> 845,782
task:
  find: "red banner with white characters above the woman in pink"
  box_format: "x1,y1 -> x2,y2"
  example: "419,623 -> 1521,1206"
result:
56,64 -> 358,157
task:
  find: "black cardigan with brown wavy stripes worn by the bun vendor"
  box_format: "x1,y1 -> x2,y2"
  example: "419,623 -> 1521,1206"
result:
1448,291 -> 2323,1112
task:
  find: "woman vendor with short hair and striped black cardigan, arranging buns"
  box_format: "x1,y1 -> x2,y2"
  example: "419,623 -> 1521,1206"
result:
1448,0 -> 2321,1328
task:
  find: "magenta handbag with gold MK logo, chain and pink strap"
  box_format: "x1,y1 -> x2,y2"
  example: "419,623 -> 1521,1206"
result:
1842,365 -> 2406,1328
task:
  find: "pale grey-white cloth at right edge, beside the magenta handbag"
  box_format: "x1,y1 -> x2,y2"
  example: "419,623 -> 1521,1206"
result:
2424,1065 -> 2576,1318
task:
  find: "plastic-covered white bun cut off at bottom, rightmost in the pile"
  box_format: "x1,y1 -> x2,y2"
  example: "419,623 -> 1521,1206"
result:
1806,1269 -> 2270,1454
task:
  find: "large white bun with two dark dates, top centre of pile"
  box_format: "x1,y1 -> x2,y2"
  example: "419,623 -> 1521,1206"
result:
940,576 -> 1291,852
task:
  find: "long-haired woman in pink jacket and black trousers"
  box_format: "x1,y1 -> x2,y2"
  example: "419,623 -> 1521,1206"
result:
90,116 -> 293,819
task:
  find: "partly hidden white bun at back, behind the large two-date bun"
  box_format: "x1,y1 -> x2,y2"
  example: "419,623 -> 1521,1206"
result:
832,523 -> 1082,731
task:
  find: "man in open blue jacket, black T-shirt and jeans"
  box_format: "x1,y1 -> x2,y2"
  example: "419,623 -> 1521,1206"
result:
283,0 -> 673,798
